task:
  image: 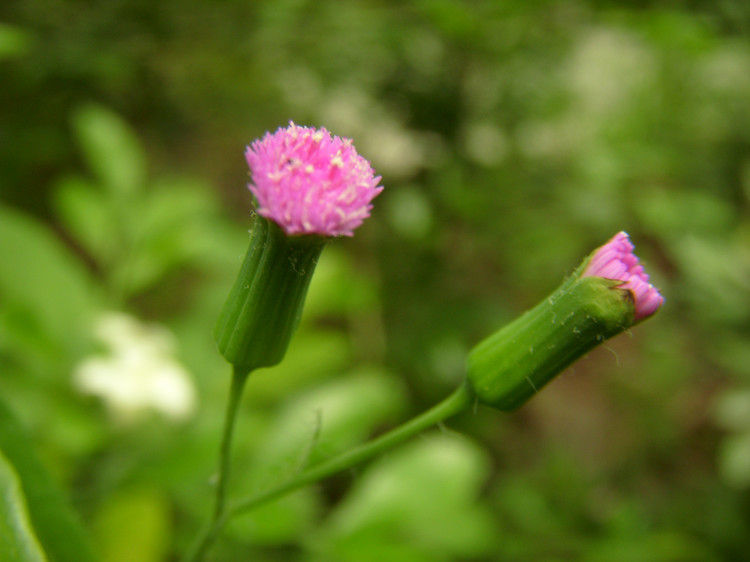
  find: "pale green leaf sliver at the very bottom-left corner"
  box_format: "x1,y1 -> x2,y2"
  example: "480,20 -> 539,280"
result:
0,453 -> 47,562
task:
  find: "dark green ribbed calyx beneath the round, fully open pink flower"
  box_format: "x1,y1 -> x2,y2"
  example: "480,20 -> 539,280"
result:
214,216 -> 325,372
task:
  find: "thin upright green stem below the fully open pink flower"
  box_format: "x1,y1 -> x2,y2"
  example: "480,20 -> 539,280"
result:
186,367 -> 249,562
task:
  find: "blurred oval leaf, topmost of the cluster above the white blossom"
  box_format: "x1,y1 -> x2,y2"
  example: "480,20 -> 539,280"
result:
73,104 -> 146,197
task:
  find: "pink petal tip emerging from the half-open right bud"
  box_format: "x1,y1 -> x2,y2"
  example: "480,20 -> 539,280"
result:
581,232 -> 664,321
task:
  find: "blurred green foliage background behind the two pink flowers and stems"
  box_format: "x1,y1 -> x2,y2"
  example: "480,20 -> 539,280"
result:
0,0 -> 750,562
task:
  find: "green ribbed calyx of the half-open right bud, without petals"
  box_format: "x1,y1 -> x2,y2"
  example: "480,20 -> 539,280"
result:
468,272 -> 635,410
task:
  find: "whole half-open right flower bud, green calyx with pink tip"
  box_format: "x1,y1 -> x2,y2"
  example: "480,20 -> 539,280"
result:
468,232 -> 664,410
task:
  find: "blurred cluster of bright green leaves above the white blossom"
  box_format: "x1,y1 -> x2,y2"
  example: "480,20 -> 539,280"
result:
50,106 -> 232,298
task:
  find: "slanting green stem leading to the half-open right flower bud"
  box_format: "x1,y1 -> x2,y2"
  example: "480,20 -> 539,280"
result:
226,384 -> 473,519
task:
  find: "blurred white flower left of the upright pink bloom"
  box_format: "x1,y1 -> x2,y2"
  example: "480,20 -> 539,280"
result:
73,313 -> 195,423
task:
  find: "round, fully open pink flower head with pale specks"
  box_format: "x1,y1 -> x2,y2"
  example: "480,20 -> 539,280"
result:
245,121 -> 383,236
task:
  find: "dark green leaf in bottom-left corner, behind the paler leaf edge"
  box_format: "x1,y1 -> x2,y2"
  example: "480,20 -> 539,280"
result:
0,396 -> 95,562
